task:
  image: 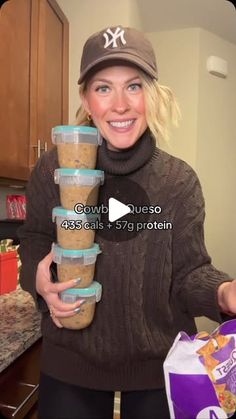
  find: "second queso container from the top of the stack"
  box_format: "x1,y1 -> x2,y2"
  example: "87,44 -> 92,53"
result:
54,169 -> 104,210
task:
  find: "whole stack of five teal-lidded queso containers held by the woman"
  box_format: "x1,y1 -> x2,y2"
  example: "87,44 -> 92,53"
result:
52,125 -> 104,329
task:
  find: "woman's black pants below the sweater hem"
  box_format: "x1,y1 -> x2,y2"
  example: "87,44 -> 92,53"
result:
38,374 -> 170,419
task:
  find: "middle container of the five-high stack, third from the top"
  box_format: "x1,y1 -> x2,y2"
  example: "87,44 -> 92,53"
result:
52,207 -> 100,250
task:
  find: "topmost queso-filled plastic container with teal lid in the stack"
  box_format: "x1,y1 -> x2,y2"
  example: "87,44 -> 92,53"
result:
52,125 -> 102,169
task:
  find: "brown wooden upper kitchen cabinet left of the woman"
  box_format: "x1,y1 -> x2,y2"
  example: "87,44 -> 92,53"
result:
0,0 -> 69,181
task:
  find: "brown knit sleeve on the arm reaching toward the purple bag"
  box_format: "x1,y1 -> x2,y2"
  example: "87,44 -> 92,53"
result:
172,165 -> 231,323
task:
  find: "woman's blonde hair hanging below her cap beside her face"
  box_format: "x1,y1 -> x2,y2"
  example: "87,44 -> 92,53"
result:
76,70 -> 181,144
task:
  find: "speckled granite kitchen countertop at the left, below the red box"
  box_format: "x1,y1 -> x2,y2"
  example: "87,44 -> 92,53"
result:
0,285 -> 41,372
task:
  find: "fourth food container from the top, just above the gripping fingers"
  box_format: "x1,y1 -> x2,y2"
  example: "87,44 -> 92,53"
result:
52,243 -> 101,288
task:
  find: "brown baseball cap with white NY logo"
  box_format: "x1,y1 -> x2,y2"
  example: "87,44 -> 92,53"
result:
78,26 -> 158,84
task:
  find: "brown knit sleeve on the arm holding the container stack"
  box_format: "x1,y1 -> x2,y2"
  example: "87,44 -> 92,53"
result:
18,150 -> 59,311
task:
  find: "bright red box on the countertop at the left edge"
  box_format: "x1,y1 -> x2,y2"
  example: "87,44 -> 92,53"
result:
0,251 -> 17,295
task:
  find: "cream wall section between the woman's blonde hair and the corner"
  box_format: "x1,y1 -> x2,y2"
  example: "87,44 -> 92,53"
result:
147,28 -> 200,168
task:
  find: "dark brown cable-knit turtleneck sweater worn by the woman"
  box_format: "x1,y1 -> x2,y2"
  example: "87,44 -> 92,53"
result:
19,132 -> 232,391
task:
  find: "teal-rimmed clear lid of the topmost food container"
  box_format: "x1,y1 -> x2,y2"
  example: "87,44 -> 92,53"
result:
51,125 -> 102,145
